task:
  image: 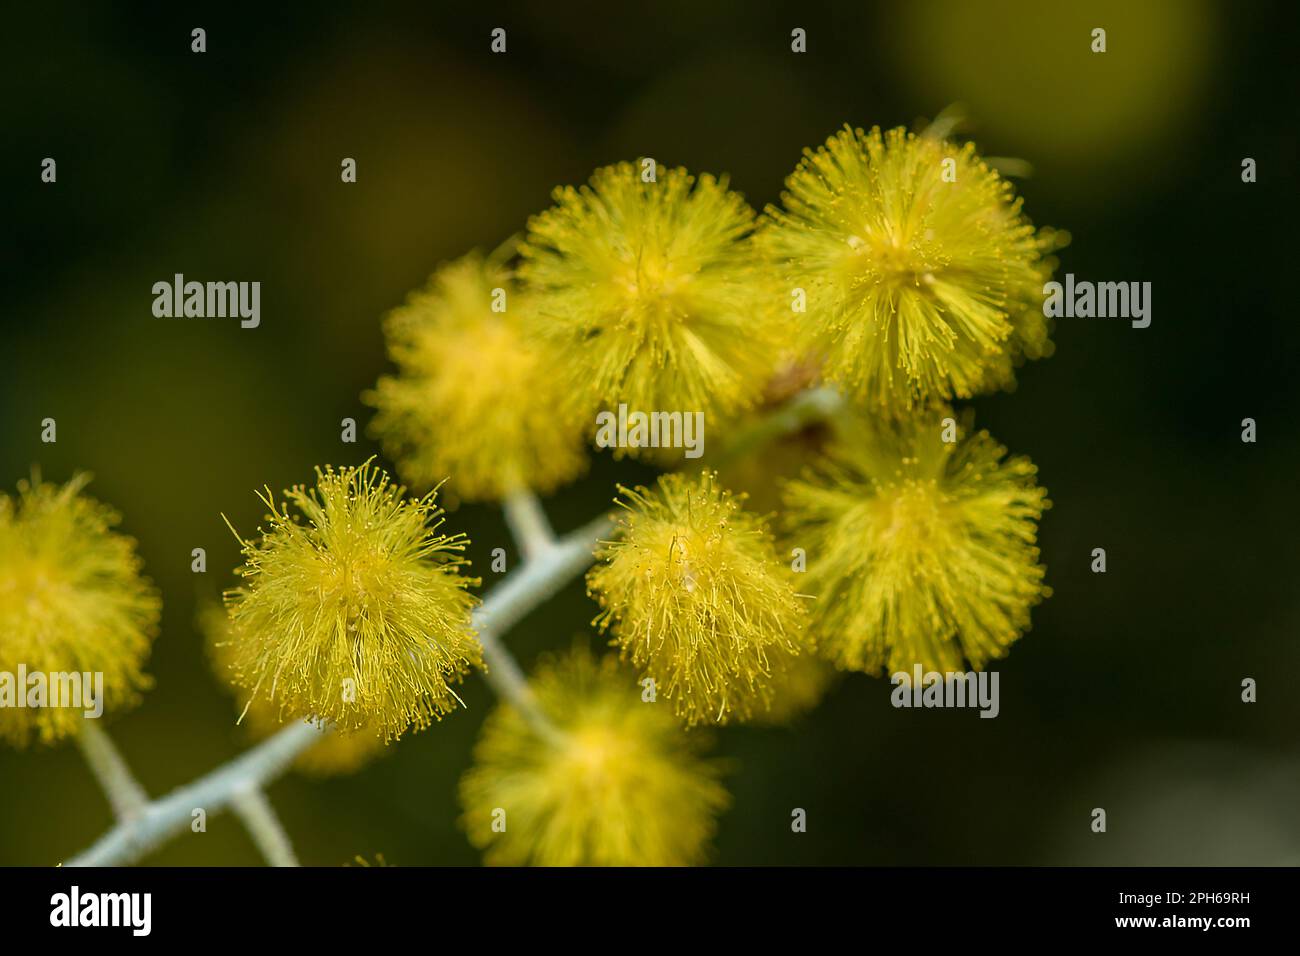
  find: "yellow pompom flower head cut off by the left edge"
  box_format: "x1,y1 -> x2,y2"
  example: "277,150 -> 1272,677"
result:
0,475 -> 161,747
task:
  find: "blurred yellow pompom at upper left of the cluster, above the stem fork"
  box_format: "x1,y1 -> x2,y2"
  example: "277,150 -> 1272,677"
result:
363,254 -> 588,501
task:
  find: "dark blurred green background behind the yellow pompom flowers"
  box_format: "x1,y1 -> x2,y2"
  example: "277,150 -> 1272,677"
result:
0,0 -> 1300,865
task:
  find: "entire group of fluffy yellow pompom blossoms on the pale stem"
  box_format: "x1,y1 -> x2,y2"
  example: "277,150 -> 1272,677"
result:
10,121 -> 1062,865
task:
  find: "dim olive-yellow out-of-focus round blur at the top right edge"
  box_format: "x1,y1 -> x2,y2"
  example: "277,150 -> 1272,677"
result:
881,0 -> 1211,174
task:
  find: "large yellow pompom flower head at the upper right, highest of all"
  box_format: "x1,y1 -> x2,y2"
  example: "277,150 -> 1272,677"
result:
758,127 -> 1065,414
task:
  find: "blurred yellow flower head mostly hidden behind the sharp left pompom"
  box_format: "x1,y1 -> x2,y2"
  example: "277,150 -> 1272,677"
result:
199,605 -> 386,777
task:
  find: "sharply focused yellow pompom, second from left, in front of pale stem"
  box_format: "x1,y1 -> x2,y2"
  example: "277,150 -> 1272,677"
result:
226,462 -> 482,740
